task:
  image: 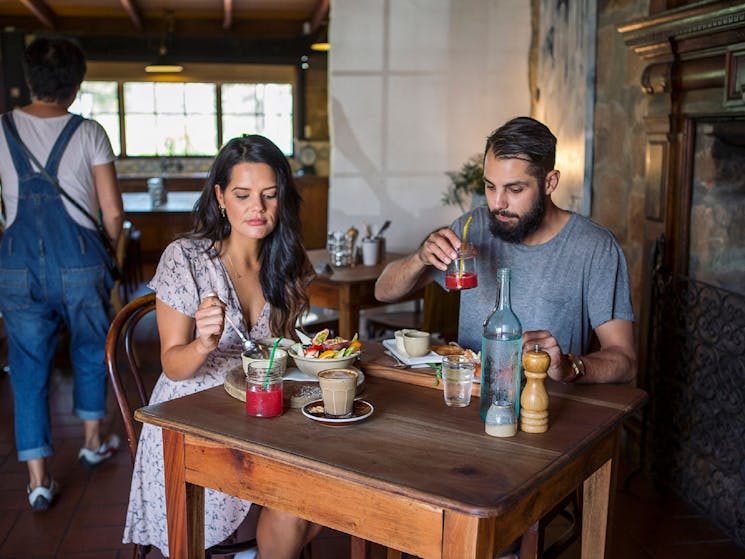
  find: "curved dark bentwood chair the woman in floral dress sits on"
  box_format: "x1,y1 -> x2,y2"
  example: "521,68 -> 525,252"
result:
105,293 -> 256,559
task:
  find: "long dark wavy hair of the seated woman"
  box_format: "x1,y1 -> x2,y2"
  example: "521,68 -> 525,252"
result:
189,134 -> 313,339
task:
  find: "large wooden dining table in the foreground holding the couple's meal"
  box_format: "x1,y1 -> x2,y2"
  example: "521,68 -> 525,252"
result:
135,343 -> 646,559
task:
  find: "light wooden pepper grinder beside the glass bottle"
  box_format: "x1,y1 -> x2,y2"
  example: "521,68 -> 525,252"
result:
520,344 -> 551,433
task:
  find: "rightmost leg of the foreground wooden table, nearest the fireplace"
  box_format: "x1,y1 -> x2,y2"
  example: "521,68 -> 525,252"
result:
582,460 -> 613,559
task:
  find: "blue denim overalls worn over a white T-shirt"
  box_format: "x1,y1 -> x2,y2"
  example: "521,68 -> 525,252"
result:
0,113 -> 113,461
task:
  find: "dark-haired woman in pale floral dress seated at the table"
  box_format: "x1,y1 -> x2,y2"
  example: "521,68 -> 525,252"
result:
124,136 -> 321,559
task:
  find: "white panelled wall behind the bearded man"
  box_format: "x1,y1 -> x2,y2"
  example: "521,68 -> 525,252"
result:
329,0 -> 531,251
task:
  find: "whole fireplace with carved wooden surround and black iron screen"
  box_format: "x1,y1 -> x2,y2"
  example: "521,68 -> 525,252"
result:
617,5 -> 745,544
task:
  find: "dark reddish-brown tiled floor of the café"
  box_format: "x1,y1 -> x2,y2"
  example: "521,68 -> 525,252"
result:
0,308 -> 745,559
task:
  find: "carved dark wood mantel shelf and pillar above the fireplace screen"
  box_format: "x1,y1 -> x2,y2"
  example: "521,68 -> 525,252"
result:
618,0 -> 745,273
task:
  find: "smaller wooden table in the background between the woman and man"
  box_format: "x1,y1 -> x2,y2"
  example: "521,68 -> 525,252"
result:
307,249 -> 424,339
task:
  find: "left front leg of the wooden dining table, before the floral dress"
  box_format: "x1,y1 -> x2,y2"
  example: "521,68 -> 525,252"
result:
163,429 -> 204,559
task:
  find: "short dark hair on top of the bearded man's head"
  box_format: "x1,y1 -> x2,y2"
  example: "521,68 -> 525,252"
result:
484,116 -> 556,180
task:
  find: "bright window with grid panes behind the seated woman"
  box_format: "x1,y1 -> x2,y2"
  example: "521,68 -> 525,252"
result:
70,81 -> 293,157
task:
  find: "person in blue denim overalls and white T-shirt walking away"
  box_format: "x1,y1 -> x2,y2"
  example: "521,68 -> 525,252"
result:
0,38 -> 124,511
